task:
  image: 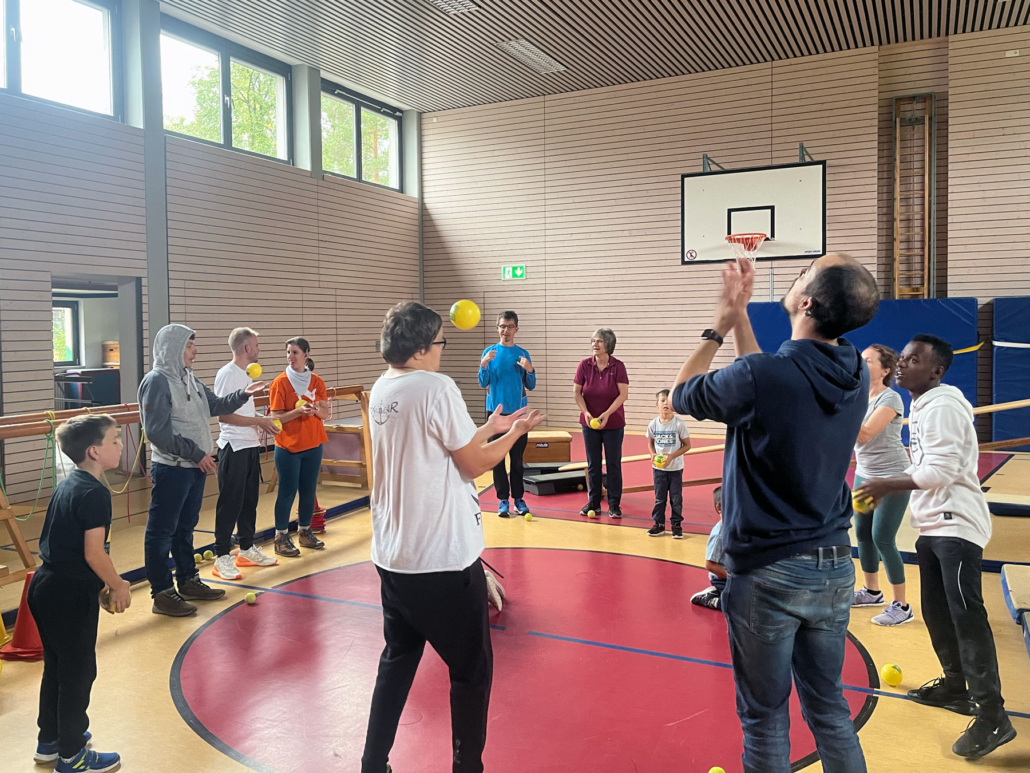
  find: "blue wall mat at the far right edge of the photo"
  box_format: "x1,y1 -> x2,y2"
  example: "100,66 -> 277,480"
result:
993,298 -> 1030,450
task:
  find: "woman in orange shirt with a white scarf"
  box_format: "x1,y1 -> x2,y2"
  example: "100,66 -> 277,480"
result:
268,338 -> 329,558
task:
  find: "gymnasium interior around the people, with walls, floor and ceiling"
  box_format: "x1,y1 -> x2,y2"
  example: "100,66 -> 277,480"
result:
0,0 -> 1030,773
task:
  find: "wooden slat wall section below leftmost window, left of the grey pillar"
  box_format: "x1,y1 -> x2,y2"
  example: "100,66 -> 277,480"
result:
0,94 -> 146,502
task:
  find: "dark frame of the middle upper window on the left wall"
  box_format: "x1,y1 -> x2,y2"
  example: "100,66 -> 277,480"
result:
158,14 -> 294,166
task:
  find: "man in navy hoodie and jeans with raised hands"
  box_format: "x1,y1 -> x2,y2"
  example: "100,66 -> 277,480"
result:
673,255 -> 880,773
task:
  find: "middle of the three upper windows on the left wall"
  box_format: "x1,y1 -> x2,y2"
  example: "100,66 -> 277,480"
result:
161,16 -> 291,162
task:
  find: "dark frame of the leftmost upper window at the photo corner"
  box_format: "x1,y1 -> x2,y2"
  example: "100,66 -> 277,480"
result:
0,0 -> 125,124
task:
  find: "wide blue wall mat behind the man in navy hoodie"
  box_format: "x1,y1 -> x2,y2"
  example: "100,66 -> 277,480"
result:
748,298 -> 976,444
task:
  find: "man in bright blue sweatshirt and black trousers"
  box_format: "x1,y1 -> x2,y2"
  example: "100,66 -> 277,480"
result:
479,310 -> 537,518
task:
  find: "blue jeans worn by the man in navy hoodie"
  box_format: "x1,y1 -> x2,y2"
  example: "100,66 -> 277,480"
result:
722,556 -> 866,773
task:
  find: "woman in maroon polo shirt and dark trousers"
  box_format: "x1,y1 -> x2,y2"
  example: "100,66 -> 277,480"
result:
573,328 -> 629,518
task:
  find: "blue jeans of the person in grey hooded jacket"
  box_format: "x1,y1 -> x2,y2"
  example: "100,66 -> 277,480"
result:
143,462 -> 207,596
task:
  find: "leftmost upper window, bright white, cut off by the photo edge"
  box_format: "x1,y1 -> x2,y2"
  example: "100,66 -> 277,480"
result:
0,0 -> 121,117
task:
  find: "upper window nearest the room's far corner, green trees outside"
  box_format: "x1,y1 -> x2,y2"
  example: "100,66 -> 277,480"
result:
321,80 -> 402,190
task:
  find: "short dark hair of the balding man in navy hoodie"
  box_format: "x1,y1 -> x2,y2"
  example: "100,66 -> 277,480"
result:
804,255 -> 880,339
